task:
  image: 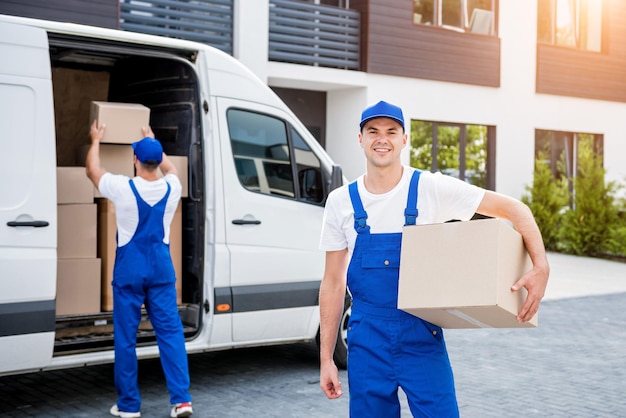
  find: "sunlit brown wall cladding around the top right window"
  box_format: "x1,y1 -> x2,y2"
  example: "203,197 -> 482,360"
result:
537,0 -> 626,102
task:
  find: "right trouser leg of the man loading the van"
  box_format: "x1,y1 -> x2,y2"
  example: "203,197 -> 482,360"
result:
146,283 -> 191,404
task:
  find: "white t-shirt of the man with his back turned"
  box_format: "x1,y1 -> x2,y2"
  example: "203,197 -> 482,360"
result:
98,173 -> 183,247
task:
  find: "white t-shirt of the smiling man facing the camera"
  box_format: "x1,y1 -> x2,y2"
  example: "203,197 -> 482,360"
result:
319,166 -> 485,253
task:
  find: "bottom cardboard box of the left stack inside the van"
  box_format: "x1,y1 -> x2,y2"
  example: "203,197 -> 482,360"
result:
56,258 -> 100,315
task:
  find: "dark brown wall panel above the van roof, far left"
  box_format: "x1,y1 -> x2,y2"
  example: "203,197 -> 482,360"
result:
0,0 -> 119,29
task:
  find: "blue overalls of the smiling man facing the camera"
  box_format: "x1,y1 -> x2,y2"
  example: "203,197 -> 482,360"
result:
348,171 -> 459,418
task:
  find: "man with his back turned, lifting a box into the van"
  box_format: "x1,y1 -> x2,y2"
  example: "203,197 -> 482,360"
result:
86,120 -> 193,418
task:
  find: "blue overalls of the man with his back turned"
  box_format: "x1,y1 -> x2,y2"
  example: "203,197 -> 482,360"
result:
113,180 -> 191,412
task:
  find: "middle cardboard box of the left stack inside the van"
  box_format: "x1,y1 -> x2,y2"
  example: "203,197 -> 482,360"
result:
57,203 -> 98,258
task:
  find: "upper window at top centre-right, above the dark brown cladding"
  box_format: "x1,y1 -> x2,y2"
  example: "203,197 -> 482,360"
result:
413,0 -> 496,35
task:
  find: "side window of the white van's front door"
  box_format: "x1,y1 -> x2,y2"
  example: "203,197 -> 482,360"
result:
227,109 -> 324,203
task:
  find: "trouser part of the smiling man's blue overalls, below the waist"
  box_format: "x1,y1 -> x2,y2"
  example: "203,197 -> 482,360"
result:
348,309 -> 459,418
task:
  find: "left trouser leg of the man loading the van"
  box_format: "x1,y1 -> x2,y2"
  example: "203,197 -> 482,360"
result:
113,285 -> 144,412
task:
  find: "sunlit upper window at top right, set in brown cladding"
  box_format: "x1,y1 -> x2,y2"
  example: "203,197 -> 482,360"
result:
537,0 -> 602,52
